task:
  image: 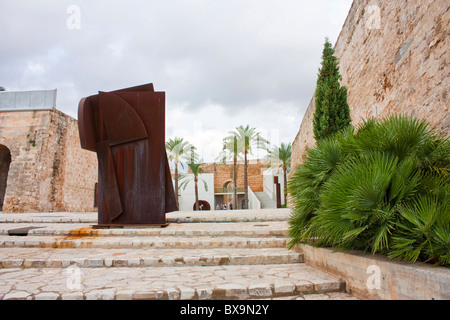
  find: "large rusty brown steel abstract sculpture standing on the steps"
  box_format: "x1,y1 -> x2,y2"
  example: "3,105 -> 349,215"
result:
78,84 -> 178,228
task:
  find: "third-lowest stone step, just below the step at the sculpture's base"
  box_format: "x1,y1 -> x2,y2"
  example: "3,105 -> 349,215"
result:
0,236 -> 287,249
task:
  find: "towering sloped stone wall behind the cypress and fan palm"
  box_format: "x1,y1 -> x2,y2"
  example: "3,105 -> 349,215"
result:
291,0 -> 450,174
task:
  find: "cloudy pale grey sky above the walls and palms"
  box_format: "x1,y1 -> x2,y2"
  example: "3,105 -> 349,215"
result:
0,0 -> 352,162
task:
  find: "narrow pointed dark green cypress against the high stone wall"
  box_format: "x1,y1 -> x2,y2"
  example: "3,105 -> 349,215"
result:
313,38 -> 351,140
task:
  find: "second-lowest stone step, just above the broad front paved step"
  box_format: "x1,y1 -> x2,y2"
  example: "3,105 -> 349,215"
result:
0,248 -> 304,269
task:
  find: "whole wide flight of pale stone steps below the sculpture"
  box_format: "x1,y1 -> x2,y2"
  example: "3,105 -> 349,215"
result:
0,209 -> 353,300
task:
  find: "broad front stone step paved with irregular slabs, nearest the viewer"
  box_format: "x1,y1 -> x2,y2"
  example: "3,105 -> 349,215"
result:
0,263 -> 345,300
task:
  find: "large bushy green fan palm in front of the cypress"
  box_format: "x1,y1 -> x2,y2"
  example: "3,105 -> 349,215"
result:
289,116 -> 450,265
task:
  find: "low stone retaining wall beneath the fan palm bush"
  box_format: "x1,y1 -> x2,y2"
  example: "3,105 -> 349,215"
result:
296,244 -> 450,300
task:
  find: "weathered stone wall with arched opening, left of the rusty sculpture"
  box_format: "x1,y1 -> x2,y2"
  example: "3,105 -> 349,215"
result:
0,110 -> 97,213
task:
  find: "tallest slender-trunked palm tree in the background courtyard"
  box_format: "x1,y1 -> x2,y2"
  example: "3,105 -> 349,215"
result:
226,125 -> 269,209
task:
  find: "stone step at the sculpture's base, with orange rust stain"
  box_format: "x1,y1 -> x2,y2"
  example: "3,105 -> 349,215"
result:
0,221 -> 289,237
